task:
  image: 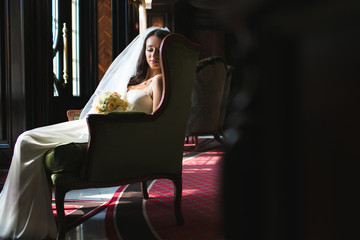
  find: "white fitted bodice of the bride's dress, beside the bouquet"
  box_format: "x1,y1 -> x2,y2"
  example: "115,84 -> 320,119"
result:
126,89 -> 153,114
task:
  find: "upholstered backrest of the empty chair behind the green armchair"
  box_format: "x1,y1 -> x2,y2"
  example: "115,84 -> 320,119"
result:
186,57 -> 227,135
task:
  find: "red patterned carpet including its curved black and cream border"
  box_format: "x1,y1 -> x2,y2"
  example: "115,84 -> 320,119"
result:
105,151 -> 223,240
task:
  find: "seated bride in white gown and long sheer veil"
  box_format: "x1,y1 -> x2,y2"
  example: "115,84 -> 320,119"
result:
0,27 -> 169,239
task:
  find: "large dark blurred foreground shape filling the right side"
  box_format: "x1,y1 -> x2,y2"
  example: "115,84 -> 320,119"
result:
221,0 -> 360,240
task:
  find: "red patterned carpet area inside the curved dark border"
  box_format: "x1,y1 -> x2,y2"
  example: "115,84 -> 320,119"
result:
146,152 -> 222,240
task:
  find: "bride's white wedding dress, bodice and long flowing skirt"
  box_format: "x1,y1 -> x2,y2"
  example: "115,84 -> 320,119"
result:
0,90 -> 153,239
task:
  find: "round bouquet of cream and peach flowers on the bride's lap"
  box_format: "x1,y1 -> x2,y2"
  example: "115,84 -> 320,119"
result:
92,92 -> 130,113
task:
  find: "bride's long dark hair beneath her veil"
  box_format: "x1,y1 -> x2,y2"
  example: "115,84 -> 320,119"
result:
128,29 -> 169,87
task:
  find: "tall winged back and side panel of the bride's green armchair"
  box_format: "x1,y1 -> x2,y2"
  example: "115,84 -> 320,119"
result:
85,34 -> 199,183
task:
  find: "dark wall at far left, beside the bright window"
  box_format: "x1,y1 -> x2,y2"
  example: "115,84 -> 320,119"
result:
0,0 -> 51,165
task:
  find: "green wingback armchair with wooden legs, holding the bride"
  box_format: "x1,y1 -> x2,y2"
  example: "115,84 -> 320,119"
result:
44,34 -> 199,239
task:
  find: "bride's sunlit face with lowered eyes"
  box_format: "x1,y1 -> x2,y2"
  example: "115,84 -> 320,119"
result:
145,36 -> 161,70
